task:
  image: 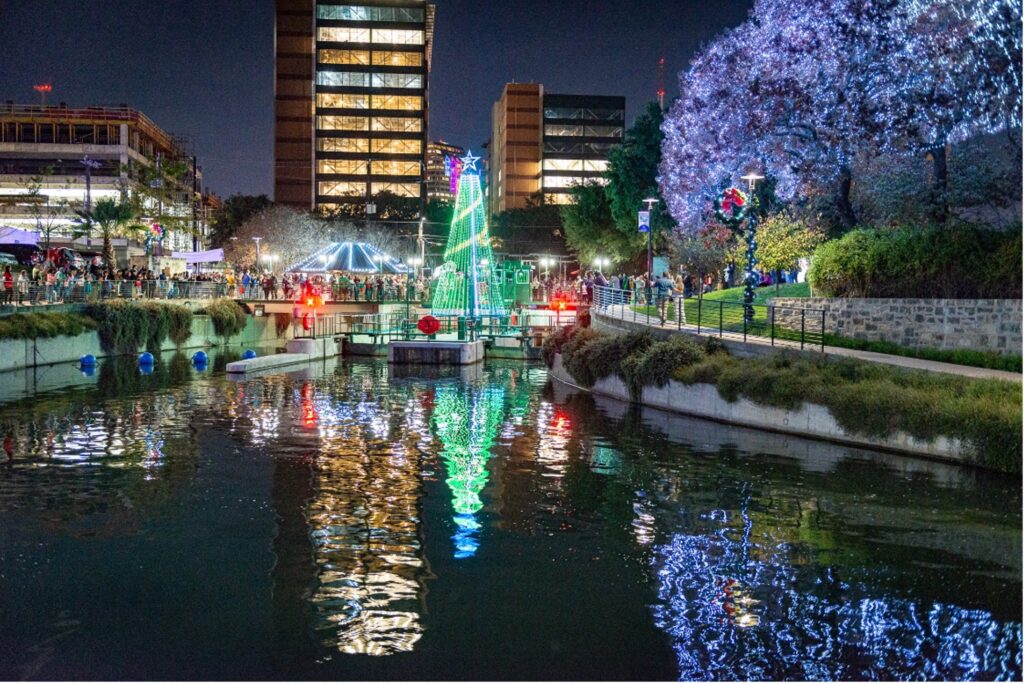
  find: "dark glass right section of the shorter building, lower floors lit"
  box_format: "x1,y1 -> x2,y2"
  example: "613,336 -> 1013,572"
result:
541,94 -> 626,204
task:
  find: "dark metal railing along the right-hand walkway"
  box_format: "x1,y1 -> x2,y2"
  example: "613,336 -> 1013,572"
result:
591,286 -> 825,351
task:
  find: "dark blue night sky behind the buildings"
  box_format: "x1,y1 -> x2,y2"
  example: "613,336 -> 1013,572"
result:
0,0 -> 753,197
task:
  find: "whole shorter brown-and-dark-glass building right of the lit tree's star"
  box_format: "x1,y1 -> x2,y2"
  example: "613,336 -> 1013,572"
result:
488,83 -> 626,215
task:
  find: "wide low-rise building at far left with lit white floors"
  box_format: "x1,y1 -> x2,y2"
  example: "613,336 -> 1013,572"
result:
0,101 -> 218,251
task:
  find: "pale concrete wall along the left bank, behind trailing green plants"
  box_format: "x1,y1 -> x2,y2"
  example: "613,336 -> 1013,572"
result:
0,315 -> 291,372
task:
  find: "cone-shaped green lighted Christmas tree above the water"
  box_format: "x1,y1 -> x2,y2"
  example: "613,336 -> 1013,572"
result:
431,153 -> 506,317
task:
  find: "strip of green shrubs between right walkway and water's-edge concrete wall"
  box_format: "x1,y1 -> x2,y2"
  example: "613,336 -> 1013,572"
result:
552,330 -> 1022,472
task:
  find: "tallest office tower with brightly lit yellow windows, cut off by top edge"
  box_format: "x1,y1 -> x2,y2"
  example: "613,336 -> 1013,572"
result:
274,0 -> 434,213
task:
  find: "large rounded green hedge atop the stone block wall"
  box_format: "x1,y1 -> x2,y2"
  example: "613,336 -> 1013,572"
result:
808,225 -> 1022,299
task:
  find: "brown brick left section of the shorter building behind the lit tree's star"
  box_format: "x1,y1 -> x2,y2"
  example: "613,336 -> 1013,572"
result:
487,83 -> 544,215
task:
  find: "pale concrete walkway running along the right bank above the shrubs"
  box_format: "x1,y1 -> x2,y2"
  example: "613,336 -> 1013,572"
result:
591,304 -> 1022,382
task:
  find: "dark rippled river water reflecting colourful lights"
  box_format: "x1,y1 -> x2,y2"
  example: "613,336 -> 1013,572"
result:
0,356 -> 1021,679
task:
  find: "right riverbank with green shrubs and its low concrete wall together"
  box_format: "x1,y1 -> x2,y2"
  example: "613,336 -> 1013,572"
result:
545,330 -> 1021,472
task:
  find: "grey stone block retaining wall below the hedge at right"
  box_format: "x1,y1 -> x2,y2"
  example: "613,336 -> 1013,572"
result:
773,297 -> 1022,353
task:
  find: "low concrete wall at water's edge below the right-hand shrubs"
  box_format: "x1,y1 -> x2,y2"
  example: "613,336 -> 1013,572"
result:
551,354 -> 970,463
